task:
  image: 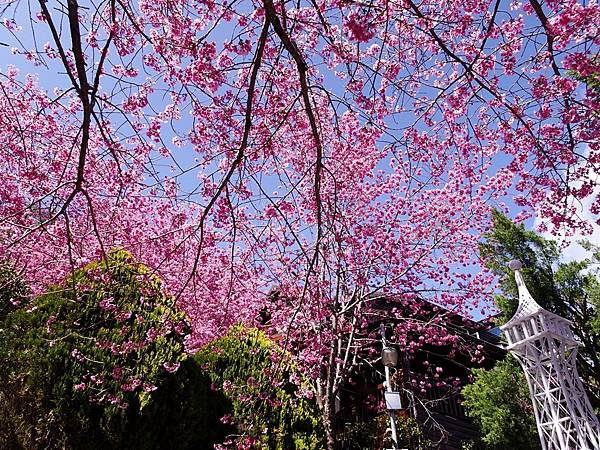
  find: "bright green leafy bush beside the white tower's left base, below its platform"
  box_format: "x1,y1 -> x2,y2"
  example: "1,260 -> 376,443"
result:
462,356 -> 540,450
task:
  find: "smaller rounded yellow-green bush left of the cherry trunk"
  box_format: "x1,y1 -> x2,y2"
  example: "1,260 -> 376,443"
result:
194,326 -> 325,450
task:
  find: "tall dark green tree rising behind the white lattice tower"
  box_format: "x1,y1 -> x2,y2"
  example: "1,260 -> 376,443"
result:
480,211 -> 600,408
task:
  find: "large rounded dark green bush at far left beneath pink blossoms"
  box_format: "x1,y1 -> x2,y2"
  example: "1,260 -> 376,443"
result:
0,251 -> 196,449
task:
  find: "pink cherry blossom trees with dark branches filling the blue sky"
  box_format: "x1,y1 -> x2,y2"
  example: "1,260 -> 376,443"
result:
0,0 -> 600,448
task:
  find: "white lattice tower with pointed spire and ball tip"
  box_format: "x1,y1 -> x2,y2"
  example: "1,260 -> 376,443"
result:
500,261 -> 600,450
